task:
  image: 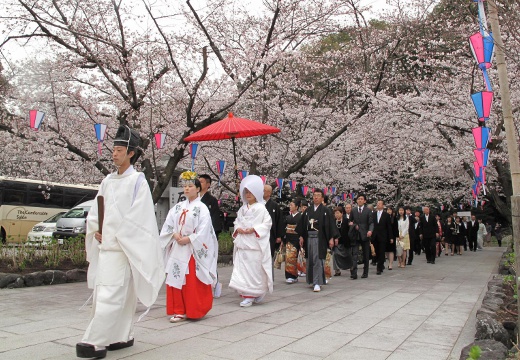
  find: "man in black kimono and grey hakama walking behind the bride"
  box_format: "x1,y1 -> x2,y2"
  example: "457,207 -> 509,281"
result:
299,189 -> 338,292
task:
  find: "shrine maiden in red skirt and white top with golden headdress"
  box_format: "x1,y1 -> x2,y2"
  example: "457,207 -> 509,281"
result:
160,171 -> 218,323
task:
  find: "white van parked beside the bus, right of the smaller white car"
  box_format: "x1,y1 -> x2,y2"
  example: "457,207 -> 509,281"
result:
52,200 -> 94,244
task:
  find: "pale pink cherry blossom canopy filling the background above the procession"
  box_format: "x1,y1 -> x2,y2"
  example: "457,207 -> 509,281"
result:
0,0 -> 520,222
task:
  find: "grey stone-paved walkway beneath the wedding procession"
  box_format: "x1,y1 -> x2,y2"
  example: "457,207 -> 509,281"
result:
0,248 -> 504,360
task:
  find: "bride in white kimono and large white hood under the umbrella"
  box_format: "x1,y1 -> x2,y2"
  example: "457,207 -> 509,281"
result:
229,175 -> 273,307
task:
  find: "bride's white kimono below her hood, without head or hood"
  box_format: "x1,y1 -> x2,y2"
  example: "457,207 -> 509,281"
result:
229,202 -> 273,297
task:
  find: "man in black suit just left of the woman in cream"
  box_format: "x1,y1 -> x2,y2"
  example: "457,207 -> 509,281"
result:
372,200 -> 395,275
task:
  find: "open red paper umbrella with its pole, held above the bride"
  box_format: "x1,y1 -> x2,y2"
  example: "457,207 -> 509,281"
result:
184,113 -> 280,188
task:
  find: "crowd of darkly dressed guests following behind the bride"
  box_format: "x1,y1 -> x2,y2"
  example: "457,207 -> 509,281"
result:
267,189 -> 501,292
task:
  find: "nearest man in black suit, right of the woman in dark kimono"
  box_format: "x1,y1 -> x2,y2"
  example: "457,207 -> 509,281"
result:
350,194 -> 374,279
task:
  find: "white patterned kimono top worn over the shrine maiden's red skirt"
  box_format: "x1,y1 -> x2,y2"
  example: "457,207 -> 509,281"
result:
160,197 -> 218,289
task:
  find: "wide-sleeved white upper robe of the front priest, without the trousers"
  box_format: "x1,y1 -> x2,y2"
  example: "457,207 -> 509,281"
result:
85,166 -> 164,307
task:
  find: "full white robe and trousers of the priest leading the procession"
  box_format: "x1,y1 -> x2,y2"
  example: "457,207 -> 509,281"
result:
82,166 -> 164,346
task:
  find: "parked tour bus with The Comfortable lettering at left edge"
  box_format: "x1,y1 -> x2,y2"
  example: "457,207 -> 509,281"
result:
0,176 -> 98,243
